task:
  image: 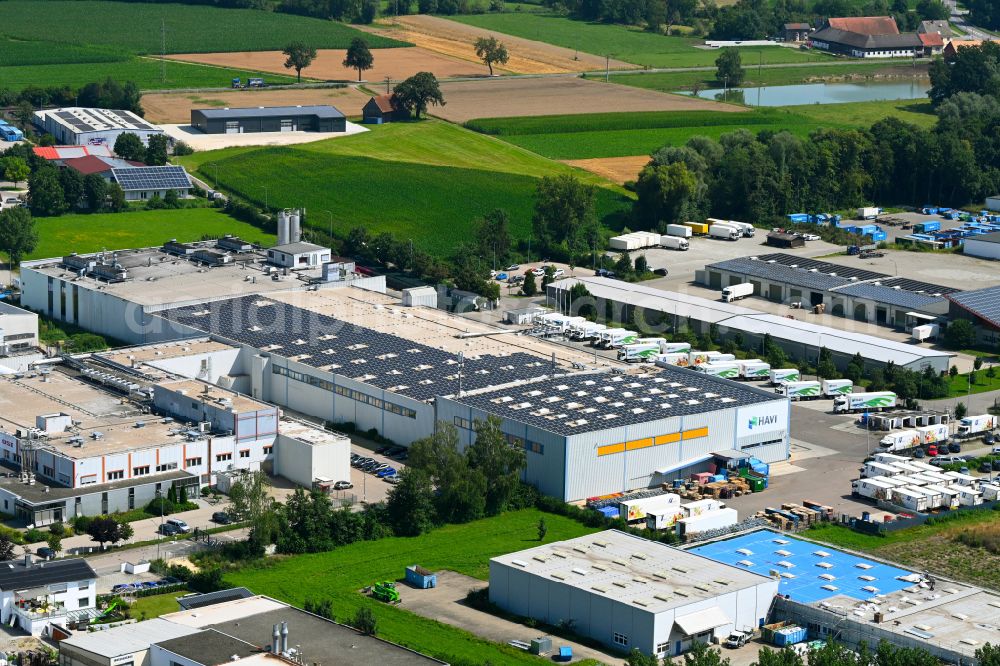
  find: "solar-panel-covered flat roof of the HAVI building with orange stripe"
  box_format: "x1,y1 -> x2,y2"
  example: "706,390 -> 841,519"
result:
452,367 -> 785,436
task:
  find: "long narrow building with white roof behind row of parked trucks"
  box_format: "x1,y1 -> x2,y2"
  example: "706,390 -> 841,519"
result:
547,273 -> 954,372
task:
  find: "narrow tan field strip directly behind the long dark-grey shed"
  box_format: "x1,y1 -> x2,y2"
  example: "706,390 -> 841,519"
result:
142,88 -> 369,124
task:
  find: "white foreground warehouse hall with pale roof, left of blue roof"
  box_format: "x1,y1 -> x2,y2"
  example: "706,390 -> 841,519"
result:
489,530 -> 778,657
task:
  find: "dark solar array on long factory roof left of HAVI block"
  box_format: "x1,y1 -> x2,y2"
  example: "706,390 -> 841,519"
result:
159,296 -> 565,400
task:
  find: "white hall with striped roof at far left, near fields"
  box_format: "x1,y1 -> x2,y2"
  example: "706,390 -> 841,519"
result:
35,106 -> 163,147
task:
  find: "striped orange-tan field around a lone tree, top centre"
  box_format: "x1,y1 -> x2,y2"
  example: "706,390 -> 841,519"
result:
359,15 -> 636,74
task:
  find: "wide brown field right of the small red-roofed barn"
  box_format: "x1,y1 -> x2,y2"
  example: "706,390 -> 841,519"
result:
431,76 -> 746,123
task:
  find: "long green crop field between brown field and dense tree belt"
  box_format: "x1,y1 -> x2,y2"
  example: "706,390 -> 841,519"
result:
466,100 -> 936,160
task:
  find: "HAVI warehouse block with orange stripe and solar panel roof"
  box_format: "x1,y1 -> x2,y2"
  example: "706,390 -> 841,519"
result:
437,367 -> 791,502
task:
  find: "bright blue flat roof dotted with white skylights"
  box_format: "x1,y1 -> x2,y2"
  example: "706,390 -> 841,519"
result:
690,530 -> 913,604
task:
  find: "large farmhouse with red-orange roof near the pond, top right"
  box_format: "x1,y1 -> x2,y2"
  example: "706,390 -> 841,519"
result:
809,16 -> 924,58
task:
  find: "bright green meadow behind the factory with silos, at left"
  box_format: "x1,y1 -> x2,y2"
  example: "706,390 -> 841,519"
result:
26,208 -> 274,259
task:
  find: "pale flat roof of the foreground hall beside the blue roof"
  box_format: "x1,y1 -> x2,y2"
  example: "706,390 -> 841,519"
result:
490,530 -> 769,613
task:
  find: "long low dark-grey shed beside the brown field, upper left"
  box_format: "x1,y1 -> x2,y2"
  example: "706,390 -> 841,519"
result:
191,104 -> 347,134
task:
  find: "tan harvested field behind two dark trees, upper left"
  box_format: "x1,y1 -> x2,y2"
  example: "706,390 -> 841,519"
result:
167,47 -> 496,86
